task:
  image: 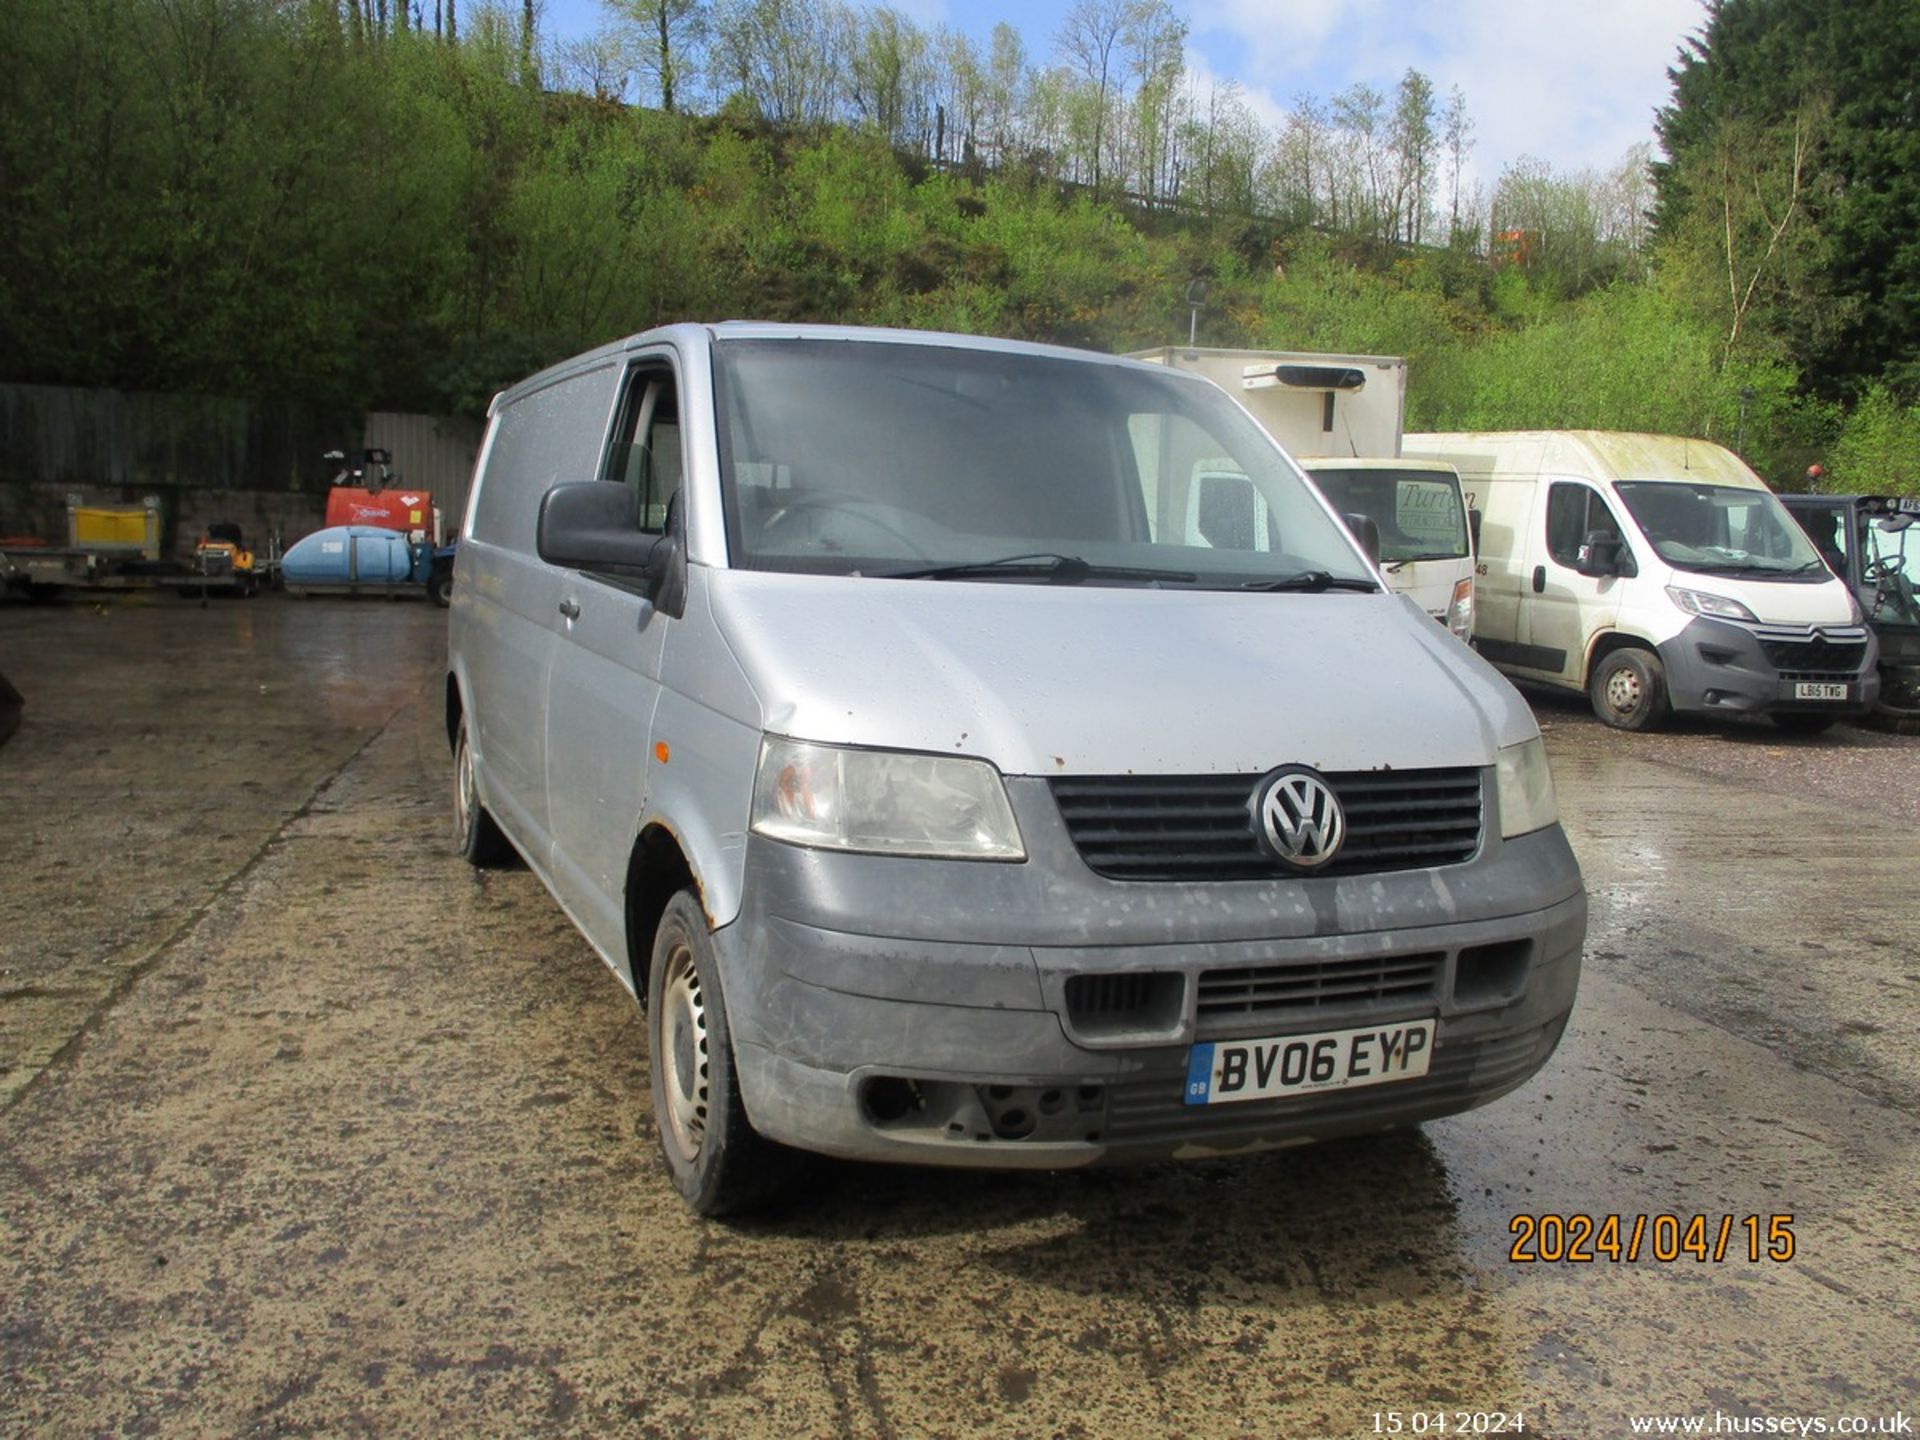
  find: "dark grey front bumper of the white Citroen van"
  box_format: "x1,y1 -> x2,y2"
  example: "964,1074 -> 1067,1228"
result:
1659,618 -> 1880,714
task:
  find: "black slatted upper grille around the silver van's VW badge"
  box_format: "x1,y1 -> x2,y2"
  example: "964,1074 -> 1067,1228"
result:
1050,766 -> 1482,881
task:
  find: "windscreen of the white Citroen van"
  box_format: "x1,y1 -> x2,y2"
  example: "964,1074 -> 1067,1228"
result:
1620,480 -> 1832,584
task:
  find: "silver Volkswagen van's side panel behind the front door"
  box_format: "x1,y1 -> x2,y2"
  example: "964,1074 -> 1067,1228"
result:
459,365 -> 614,856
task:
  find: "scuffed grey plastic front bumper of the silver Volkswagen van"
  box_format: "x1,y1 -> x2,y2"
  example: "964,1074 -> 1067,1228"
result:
714,780 -> 1586,1169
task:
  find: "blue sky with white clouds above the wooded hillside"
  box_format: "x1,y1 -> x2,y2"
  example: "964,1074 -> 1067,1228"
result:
543,0 -> 1705,190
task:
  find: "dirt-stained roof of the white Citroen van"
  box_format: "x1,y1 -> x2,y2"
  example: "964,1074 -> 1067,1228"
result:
1404,430 -> 1766,490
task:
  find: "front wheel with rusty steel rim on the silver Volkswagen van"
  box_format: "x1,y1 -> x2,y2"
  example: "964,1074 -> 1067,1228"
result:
647,891 -> 797,1215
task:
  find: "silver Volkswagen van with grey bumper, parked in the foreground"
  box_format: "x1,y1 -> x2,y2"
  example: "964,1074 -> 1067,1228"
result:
445,324 -> 1586,1213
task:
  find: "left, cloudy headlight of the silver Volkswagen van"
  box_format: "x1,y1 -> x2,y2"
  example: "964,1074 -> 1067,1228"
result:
751,735 -> 1027,860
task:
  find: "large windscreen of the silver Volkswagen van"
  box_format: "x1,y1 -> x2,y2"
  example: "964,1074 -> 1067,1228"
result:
714,340 -> 1375,589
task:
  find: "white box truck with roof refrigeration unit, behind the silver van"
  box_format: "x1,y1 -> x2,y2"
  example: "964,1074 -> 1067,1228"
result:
1133,346 -> 1475,639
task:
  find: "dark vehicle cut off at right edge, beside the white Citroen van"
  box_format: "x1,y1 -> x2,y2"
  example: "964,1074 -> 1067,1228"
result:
1780,495 -> 1920,735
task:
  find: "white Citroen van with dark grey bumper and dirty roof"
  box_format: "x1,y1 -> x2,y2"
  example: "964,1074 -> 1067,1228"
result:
1405,430 -> 1880,732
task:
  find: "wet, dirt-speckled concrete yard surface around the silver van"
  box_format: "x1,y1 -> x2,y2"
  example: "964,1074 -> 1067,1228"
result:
0,599 -> 1920,1440
